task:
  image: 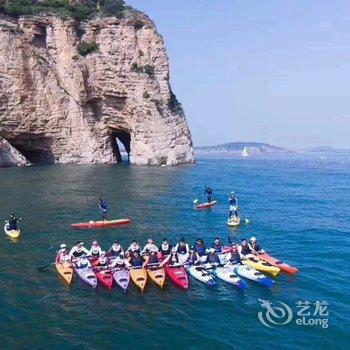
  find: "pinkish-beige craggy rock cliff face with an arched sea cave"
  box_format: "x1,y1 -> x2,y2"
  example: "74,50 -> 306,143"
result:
0,16 -> 194,165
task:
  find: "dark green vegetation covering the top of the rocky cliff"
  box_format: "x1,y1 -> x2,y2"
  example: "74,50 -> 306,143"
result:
0,0 -> 125,20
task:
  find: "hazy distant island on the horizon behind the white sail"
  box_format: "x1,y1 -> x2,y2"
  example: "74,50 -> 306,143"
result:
194,142 -> 293,155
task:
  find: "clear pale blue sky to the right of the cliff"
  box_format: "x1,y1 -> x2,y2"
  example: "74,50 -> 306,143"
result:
127,0 -> 350,148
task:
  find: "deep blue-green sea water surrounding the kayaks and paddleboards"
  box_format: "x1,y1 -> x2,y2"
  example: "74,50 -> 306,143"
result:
0,156 -> 350,349
